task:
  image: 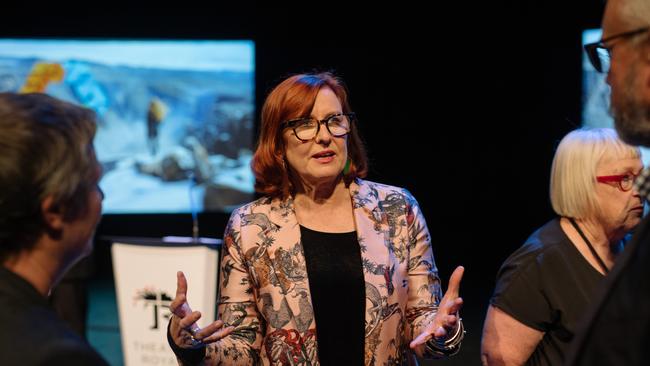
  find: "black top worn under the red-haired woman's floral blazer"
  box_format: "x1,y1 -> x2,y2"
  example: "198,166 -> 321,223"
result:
300,226 -> 366,366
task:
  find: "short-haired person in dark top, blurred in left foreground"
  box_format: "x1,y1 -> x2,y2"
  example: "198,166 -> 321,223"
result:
0,93 -> 107,366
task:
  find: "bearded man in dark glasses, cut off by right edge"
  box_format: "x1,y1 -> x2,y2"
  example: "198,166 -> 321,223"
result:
567,0 -> 650,365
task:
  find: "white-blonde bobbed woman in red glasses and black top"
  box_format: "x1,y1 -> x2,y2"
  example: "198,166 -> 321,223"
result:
481,129 -> 643,365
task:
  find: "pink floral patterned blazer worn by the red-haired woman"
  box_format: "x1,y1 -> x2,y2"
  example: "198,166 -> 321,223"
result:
206,179 -> 456,365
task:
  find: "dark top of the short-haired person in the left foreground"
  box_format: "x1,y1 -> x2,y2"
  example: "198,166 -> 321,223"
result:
0,265 -> 108,366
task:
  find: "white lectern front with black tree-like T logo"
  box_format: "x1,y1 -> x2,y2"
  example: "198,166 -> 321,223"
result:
111,241 -> 219,366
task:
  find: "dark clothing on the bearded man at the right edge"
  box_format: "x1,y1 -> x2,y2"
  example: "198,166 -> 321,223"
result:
567,213 -> 650,366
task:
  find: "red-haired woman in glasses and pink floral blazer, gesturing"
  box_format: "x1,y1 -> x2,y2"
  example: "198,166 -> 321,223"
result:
169,73 -> 464,365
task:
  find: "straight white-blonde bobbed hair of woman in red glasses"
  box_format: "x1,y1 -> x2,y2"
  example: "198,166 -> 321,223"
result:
550,128 -> 641,218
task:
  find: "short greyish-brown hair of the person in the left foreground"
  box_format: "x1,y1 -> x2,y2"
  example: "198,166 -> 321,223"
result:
0,93 -> 99,260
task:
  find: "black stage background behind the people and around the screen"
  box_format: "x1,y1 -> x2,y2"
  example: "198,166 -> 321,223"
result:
0,0 -> 603,365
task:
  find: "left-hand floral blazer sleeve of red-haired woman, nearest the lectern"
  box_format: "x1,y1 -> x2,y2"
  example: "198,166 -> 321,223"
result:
206,210 -> 265,365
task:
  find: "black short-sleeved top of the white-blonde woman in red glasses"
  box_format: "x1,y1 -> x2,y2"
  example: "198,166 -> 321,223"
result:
490,219 -> 604,365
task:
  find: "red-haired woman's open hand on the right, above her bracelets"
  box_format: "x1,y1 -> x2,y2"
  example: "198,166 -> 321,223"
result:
410,266 -> 465,348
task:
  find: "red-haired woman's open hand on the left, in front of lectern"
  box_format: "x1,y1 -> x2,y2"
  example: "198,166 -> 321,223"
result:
169,271 -> 235,348
